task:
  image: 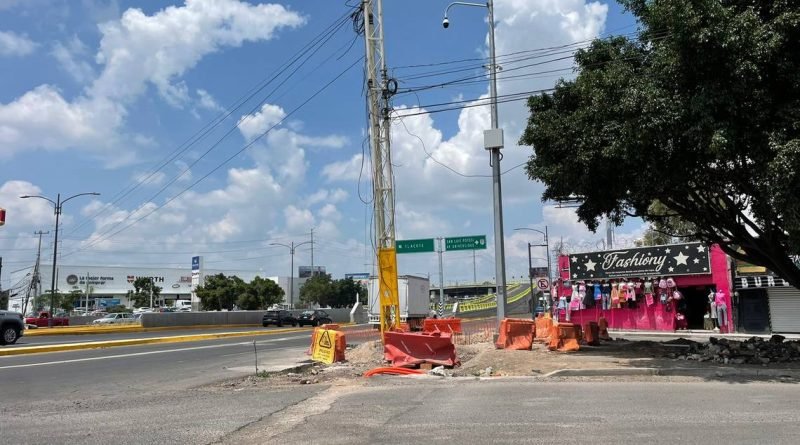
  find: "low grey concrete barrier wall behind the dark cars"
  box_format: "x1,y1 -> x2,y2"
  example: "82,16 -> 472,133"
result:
142,308 -> 360,328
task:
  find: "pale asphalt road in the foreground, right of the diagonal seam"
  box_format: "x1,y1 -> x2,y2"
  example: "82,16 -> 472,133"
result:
224,377 -> 800,445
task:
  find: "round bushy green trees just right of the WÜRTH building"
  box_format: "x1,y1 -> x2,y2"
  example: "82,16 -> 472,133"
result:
195,273 -> 284,311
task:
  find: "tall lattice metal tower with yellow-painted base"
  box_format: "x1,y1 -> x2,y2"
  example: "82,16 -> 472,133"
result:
361,0 -> 400,336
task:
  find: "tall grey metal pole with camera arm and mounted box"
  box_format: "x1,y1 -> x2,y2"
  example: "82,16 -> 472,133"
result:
442,0 -> 506,323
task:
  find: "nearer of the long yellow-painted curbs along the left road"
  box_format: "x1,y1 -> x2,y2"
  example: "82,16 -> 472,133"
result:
0,328 -> 309,356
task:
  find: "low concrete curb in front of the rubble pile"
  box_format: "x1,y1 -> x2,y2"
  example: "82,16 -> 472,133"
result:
540,368 -> 800,378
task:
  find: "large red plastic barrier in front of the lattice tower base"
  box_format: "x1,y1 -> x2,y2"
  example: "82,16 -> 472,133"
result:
383,332 -> 460,366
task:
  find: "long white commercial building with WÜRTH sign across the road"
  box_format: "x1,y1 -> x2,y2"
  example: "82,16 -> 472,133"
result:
9,265 -> 305,311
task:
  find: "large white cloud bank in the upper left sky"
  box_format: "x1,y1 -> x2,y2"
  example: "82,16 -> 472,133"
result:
0,0 -> 305,163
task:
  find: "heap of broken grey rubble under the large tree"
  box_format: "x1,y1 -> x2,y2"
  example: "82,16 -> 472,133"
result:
670,335 -> 800,366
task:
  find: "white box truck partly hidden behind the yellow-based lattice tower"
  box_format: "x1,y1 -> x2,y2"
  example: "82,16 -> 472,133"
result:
368,275 -> 431,330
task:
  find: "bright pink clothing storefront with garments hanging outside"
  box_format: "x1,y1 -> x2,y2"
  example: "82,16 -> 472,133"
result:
551,243 -> 733,332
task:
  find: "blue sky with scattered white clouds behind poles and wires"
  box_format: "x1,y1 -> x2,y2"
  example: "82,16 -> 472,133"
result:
0,0 -> 641,287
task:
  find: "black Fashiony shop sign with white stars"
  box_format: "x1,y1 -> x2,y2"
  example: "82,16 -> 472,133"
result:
569,243 -> 711,280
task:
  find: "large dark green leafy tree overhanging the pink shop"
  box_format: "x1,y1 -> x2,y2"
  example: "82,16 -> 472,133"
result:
520,0 -> 800,287
